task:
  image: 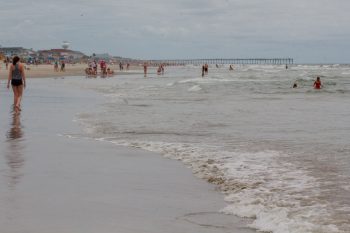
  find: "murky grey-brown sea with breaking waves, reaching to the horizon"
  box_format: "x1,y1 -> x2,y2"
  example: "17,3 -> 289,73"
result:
70,65 -> 350,233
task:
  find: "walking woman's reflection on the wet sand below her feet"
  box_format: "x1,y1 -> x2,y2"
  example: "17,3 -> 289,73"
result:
5,112 -> 24,188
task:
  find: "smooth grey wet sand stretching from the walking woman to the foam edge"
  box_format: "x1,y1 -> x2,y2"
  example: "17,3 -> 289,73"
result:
0,79 -> 255,233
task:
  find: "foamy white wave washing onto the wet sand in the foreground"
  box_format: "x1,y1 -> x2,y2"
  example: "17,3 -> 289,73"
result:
87,139 -> 339,233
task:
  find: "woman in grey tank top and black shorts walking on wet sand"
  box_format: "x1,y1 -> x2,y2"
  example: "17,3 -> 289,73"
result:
7,56 -> 26,111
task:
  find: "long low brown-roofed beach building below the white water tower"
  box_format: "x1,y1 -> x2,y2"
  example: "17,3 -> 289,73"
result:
38,49 -> 86,63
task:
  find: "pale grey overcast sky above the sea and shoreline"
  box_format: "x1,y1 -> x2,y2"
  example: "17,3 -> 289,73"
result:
0,0 -> 350,63
